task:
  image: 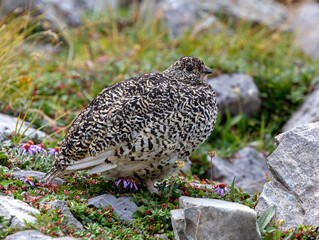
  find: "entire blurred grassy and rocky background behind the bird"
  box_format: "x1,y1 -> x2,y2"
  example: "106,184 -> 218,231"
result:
0,0 -> 319,180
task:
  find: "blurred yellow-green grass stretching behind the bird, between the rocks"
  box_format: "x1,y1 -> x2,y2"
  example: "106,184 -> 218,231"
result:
0,12 -> 319,157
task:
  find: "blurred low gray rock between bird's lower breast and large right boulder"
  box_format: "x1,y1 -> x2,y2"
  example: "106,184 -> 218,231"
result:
207,147 -> 271,194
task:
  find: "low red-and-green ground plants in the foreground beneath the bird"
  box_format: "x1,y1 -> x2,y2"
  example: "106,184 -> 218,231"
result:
0,147 -> 256,239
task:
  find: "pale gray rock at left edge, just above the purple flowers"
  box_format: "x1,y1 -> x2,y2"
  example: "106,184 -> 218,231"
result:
0,113 -> 46,140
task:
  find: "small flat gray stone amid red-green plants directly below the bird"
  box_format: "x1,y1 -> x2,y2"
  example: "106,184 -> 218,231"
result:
88,194 -> 137,221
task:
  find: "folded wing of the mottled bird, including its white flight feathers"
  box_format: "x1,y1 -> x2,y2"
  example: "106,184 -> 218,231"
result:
76,84 -> 186,173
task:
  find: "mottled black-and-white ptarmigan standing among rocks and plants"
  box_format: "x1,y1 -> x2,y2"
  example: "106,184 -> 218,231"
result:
44,57 -> 217,192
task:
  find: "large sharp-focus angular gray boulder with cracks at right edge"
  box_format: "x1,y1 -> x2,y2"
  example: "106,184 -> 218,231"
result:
256,122 -> 319,229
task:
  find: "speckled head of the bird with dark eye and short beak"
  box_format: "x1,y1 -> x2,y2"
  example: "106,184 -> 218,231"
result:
163,57 -> 213,85
